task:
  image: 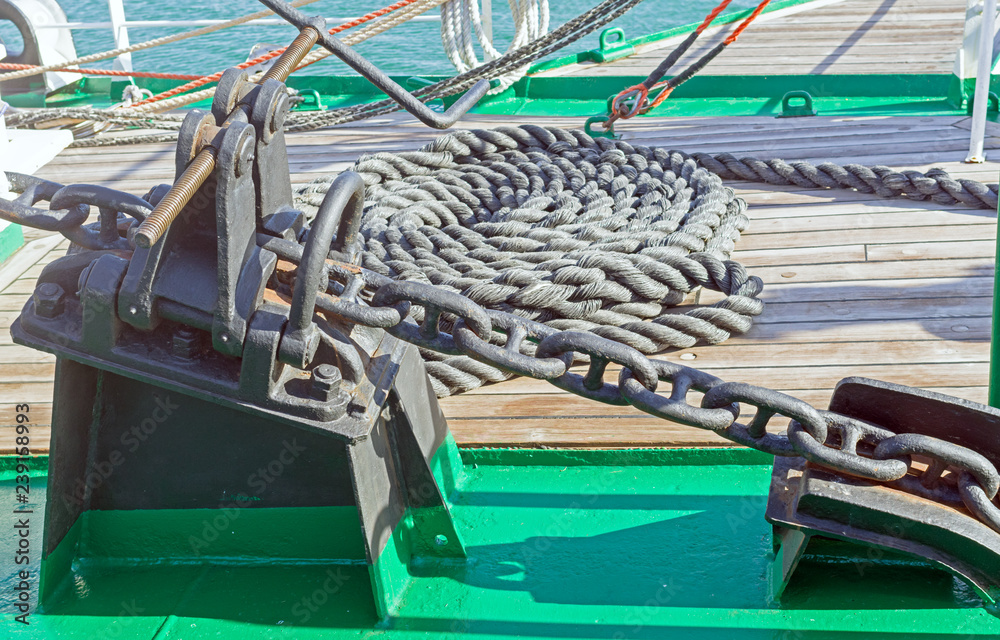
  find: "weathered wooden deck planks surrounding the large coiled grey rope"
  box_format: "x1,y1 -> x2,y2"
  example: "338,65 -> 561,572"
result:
0,111 -> 1000,452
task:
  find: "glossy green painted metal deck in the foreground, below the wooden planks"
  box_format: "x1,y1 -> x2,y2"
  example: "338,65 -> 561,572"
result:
0,449 -> 1000,640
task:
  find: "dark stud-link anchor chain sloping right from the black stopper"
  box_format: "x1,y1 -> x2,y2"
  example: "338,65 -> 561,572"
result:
319,261 -> 1000,532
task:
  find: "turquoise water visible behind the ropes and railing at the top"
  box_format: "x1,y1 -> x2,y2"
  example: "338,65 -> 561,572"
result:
0,0 -> 756,74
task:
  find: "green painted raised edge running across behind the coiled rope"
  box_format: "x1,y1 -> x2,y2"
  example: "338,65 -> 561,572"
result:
39,74 -> 1000,119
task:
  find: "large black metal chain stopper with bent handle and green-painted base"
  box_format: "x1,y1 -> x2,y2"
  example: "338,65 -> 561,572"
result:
11,13 -> 488,617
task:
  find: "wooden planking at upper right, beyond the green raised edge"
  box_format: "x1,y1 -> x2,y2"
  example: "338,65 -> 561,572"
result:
539,0 -> 966,76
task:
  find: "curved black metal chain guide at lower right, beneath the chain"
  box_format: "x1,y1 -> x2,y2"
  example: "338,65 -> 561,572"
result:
766,378 -> 1000,609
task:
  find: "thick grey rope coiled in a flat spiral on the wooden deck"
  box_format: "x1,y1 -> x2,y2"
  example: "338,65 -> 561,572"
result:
298,125 -> 764,396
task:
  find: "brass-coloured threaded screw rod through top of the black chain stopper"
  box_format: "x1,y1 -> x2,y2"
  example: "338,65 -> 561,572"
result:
134,27 -> 319,249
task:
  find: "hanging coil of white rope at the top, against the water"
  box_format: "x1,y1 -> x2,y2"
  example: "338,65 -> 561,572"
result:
441,0 -> 549,94
